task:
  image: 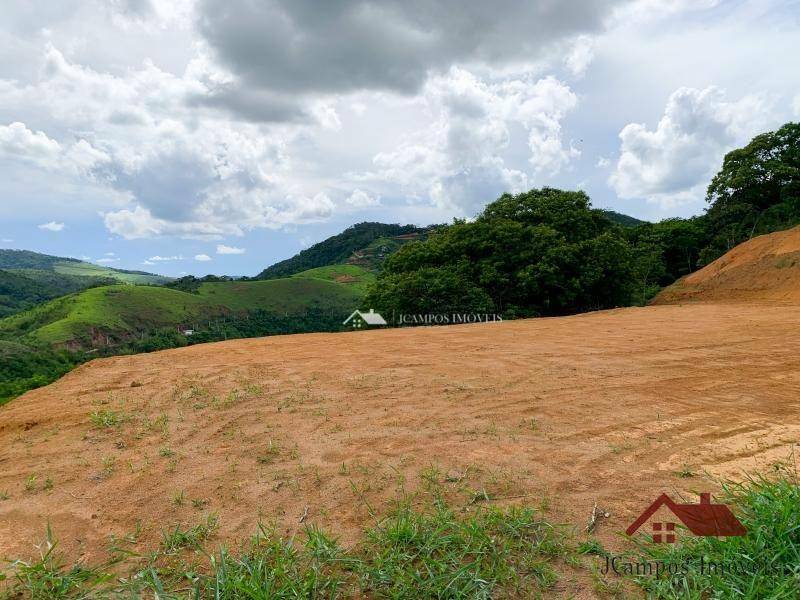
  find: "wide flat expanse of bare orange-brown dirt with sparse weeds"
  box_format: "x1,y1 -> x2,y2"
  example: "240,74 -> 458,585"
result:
0,303 -> 800,592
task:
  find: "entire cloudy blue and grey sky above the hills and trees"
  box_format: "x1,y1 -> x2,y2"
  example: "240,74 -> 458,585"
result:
0,0 -> 800,276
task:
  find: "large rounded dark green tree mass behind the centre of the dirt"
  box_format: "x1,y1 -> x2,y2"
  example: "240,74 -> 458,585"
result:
365,188 -> 635,316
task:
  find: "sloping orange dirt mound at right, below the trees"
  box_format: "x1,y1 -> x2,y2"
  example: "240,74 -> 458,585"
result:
653,227 -> 800,304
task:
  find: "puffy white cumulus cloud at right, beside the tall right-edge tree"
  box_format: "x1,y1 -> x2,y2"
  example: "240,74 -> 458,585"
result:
609,87 -> 769,206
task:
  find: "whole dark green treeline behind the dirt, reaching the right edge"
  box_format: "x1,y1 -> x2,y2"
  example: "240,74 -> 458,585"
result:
364,123 -> 800,318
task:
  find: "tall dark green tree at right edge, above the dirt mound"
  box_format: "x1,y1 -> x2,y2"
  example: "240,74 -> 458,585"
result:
702,123 -> 800,262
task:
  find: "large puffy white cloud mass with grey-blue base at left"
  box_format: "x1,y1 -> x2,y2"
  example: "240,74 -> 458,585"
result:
0,45 -> 340,239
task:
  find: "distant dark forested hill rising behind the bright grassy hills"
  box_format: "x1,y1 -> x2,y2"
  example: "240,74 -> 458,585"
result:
255,222 -> 427,279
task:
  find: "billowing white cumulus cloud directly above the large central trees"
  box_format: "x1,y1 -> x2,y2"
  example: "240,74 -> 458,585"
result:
356,68 -> 580,215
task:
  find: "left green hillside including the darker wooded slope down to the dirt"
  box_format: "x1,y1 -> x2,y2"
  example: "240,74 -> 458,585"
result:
0,265 -> 374,404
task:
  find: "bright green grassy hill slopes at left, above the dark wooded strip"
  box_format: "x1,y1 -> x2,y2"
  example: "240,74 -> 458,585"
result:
0,265 -> 373,349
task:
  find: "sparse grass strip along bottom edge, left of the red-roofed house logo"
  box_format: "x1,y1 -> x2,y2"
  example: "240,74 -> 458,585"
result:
0,500 -> 568,600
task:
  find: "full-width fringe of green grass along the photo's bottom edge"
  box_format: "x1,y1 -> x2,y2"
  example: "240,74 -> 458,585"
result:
0,476 -> 800,600
